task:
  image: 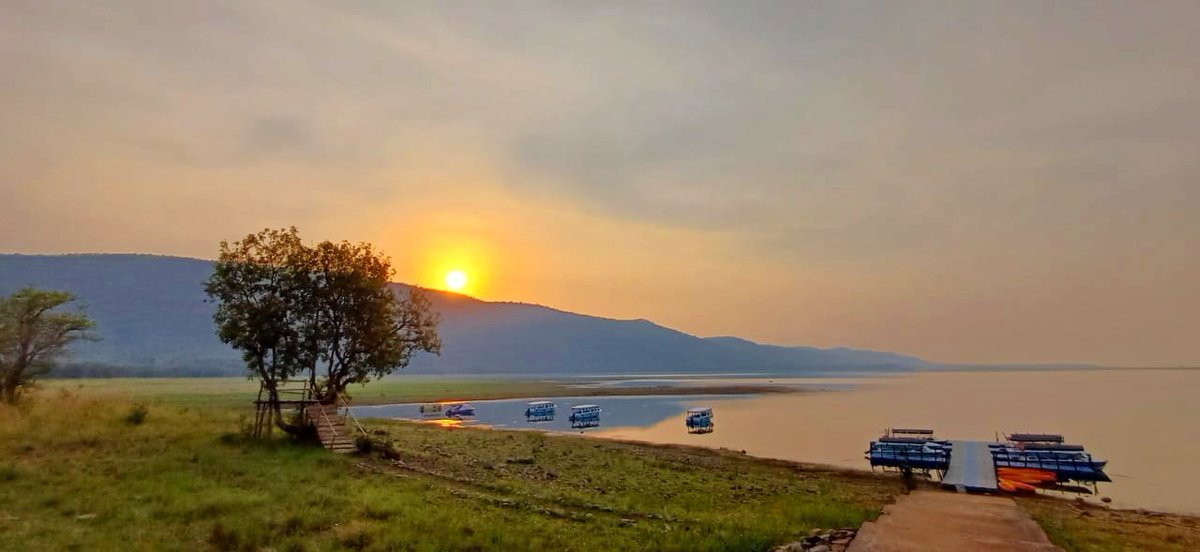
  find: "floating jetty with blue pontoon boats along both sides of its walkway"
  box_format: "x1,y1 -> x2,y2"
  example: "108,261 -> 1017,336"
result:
866,428 -> 1111,492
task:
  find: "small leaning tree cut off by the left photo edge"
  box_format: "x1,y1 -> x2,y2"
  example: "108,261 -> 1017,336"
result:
0,288 -> 96,403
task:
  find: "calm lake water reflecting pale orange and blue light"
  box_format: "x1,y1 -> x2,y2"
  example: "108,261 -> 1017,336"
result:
355,370 -> 1200,514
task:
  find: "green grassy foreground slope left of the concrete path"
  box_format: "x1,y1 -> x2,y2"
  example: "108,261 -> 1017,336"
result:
0,391 -> 899,551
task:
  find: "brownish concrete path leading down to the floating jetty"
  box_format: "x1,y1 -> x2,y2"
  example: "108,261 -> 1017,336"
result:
848,491 -> 1061,552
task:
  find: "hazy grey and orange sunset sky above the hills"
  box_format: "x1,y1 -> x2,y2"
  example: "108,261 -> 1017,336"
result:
0,0 -> 1200,366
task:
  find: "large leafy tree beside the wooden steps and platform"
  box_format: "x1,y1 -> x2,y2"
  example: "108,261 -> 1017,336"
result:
205,228 -> 442,431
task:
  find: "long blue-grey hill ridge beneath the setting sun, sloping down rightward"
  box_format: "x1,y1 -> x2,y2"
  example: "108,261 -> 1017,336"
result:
0,254 -> 929,376
